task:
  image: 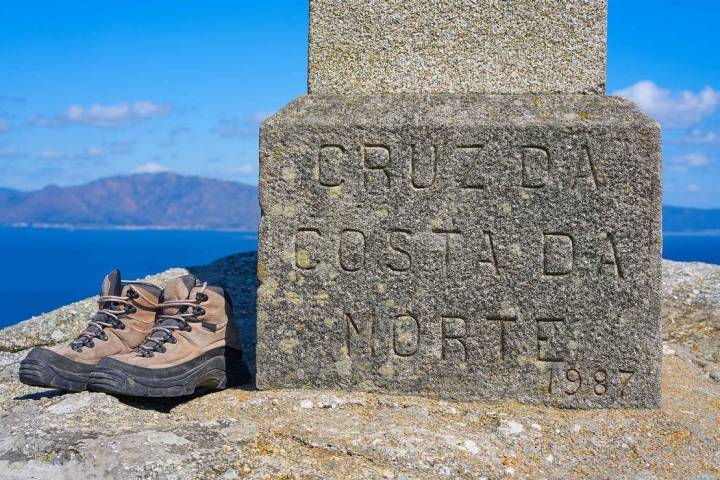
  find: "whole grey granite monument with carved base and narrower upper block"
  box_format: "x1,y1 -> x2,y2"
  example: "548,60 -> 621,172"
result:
257,0 -> 662,408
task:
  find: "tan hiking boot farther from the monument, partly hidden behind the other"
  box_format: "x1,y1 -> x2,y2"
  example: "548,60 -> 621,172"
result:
20,270 -> 162,392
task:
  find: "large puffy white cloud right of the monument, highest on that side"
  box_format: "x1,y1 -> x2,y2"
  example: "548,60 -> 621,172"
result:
615,80 -> 720,128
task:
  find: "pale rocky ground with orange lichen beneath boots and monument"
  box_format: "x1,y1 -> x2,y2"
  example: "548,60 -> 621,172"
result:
0,255 -> 720,480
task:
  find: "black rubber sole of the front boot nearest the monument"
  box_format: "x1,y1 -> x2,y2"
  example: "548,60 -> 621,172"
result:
88,347 -> 250,397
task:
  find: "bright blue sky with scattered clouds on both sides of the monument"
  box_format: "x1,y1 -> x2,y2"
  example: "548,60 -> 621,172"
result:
0,0 -> 720,207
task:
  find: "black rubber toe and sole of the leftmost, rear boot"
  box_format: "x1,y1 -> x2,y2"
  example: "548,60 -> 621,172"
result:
20,348 -> 95,392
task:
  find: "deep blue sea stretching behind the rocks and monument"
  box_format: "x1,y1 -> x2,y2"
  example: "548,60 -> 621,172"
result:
0,227 -> 720,328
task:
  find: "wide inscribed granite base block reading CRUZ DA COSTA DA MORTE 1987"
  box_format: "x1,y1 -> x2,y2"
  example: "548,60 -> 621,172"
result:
260,97 -> 662,408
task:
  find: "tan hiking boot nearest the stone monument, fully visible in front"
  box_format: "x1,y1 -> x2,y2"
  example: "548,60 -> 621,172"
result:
88,275 -> 249,397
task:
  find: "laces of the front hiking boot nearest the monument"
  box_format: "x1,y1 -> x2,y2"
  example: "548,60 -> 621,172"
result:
138,282 -> 208,357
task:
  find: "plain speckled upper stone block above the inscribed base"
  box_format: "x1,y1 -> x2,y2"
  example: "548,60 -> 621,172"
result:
309,0 -> 607,94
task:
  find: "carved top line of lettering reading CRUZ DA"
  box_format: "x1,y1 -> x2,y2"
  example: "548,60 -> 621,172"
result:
314,143 -> 605,193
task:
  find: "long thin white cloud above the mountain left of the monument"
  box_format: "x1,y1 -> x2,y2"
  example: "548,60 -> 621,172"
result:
30,101 -> 172,128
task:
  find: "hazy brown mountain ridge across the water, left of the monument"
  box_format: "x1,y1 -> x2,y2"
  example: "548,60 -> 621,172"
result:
0,173 -> 260,231
